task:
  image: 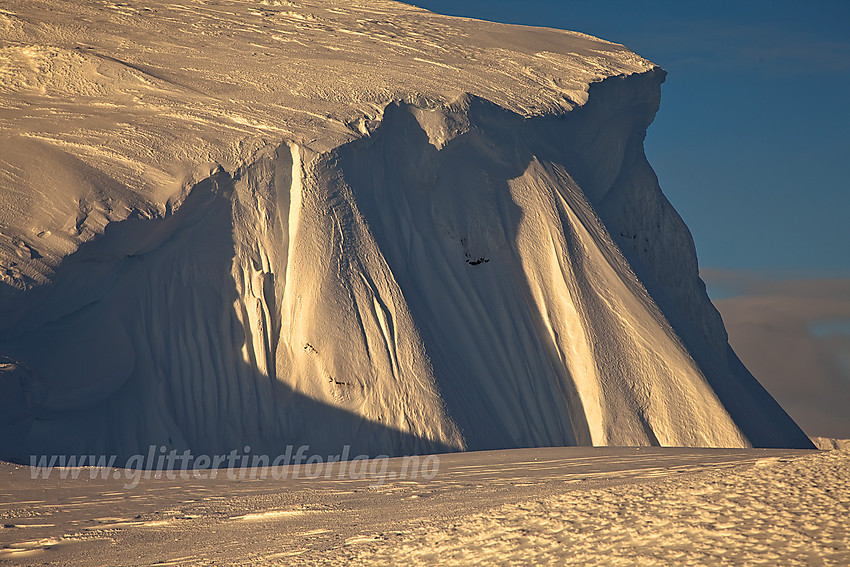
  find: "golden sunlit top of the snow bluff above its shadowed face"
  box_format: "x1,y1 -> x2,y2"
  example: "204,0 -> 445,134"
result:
0,0 -> 656,185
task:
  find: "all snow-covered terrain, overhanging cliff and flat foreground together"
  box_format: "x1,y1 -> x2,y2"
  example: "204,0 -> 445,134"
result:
0,0 -> 836,565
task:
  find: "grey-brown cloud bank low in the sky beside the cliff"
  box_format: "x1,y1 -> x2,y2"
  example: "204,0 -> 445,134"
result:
702,270 -> 850,438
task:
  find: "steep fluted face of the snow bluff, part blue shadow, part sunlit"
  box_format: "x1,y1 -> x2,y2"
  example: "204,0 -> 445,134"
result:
0,2 -> 811,460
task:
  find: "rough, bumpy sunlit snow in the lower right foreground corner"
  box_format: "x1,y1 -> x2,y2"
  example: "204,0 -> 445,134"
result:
344,450 -> 850,565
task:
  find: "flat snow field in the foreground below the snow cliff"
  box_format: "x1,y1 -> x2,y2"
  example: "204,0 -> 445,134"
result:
0,448 -> 850,566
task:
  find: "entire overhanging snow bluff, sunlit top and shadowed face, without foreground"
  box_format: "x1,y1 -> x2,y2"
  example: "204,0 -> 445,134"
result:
0,0 -> 811,459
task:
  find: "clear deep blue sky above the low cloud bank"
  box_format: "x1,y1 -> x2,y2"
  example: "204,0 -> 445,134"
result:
404,0 -> 850,282
